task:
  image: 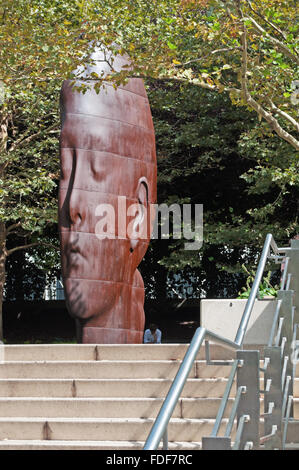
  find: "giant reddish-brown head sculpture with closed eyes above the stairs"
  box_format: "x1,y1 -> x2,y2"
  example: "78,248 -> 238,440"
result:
59,52 -> 156,344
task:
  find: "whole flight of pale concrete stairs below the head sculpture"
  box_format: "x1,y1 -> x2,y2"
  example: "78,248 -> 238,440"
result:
0,344 -> 299,450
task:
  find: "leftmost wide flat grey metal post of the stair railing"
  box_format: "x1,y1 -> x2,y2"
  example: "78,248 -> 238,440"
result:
237,350 -> 260,449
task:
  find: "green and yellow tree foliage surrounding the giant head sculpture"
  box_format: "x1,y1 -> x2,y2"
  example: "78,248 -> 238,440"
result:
0,0 -> 299,336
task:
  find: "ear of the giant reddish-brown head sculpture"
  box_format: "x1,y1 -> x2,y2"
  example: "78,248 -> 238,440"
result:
130,176 -> 149,251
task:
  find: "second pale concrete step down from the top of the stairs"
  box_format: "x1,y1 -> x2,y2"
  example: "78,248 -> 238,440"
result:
0,360 -> 236,379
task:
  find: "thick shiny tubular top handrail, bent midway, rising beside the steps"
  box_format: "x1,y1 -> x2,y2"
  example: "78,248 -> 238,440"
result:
143,234 -> 279,450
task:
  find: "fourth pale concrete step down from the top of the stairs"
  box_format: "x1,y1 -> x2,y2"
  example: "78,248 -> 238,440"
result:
0,398 -> 237,419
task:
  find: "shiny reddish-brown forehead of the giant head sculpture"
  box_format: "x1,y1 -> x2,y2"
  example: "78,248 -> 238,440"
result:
60,78 -> 156,163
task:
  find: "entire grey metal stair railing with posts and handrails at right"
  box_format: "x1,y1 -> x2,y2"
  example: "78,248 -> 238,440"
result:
144,234 -> 299,450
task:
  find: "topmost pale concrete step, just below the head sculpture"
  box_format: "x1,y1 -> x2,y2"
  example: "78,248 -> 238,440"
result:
1,344 -> 235,362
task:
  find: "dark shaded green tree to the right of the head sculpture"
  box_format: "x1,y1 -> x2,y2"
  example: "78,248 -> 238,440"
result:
141,77 -> 298,297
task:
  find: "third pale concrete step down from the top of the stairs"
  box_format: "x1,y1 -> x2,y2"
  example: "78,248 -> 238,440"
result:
0,377 -> 235,398
